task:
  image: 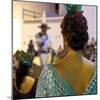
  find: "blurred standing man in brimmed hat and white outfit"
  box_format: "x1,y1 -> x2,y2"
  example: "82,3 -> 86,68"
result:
36,23 -> 51,67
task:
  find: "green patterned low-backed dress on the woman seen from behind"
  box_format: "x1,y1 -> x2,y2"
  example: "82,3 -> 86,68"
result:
36,64 -> 97,97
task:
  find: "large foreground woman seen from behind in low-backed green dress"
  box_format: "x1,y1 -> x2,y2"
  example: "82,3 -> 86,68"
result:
36,5 -> 97,97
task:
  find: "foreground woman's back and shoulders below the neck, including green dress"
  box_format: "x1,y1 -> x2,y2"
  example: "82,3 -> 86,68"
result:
37,50 -> 96,97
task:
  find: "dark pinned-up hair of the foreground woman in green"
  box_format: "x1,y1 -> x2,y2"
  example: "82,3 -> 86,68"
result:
61,12 -> 88,50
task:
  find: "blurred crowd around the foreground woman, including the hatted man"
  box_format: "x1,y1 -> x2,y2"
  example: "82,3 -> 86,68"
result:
13,24 -> 97,98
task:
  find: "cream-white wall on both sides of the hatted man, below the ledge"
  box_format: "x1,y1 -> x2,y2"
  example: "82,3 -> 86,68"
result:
22,19 -> 63,50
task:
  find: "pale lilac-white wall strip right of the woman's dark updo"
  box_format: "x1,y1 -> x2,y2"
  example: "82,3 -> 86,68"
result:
83,6 -> 97,41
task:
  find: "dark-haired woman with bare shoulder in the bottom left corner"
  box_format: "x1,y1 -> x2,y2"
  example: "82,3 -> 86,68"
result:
13,61 -> 37,99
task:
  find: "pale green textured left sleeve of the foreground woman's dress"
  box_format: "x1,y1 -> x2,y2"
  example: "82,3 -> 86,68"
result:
36,65 -> 55,97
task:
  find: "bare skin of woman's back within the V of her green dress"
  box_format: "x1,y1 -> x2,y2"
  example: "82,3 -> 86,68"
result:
54,58 -> 95,94
